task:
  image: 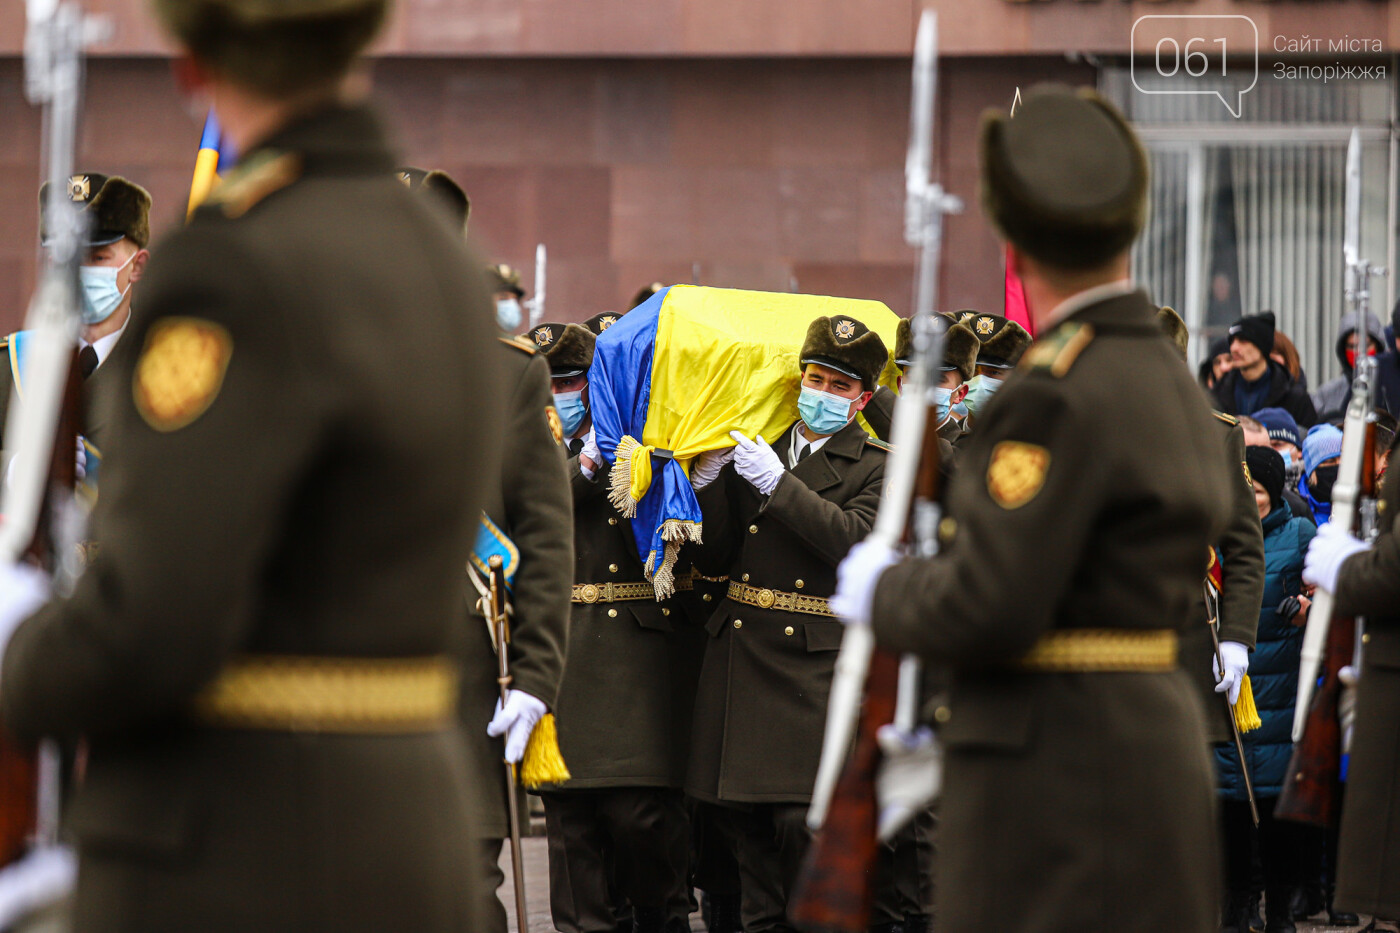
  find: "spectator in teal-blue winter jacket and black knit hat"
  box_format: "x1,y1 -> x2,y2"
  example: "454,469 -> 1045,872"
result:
1215,447 -> 1320,933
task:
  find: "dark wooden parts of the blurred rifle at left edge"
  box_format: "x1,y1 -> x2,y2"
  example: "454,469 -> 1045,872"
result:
0,350 -> 83,867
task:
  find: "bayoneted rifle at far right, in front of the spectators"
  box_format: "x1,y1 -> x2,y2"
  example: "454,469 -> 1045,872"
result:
1274,130 -> 1386,827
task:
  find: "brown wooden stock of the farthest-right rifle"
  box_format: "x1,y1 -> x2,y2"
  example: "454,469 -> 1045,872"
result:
1274,419 -> 1376,827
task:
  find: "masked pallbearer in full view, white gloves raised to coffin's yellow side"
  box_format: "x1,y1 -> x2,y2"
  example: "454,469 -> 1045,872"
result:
686,315 -> 889,933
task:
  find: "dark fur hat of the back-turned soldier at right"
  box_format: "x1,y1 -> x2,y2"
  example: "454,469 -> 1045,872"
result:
979,85 -> 1148,270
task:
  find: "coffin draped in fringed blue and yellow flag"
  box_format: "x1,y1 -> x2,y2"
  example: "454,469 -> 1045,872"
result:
588,286 -> 899,600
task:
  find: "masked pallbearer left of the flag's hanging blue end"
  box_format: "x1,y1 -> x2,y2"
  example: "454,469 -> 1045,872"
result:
528,324 -> 694,933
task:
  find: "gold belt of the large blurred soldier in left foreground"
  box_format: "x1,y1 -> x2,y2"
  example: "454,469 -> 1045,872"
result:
195,656 -> 458,734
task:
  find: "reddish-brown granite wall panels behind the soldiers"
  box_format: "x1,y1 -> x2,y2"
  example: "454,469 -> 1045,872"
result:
0,57 -> 1092,329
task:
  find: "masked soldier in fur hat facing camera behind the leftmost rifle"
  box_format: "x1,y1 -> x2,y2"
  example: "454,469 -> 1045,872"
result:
0,172 -> 151,453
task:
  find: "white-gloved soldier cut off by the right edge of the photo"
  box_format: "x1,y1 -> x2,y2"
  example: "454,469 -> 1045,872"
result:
1303,431 -> 1400,922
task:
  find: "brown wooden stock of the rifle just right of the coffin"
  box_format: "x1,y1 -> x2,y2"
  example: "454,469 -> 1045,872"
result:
788,406 -> 942,933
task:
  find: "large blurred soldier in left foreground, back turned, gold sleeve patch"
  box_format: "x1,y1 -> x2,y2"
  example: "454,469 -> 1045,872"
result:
0,0 -> 500,933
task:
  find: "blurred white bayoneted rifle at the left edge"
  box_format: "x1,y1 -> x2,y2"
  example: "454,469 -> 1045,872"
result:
0,0 -> 109,927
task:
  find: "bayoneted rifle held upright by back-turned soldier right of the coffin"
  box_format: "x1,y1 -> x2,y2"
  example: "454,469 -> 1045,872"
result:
790,11 -> 962,933
